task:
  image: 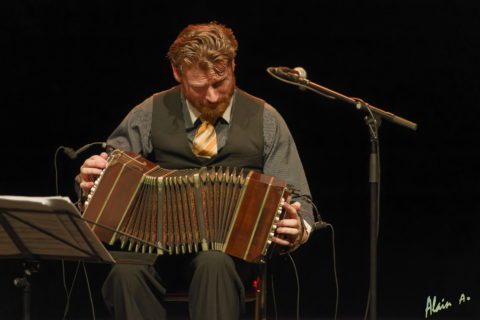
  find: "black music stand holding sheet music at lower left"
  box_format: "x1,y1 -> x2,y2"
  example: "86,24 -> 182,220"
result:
0,196 -> 115,320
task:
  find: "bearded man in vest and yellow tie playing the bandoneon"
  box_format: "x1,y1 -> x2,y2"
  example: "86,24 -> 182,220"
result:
80,22 -> 313,320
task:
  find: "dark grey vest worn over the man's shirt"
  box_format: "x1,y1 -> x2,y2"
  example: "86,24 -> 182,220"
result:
151,86 -> 264,171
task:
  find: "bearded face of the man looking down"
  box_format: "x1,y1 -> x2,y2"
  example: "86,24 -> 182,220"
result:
174,65 -> 235,123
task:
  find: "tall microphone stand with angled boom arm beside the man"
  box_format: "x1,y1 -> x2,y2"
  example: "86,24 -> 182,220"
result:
267,68 -> 417,320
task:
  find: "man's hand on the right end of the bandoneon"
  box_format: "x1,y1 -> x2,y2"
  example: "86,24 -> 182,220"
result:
272,202 -> 308,248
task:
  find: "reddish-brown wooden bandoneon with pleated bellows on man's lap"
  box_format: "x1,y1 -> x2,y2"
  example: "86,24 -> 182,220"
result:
83,150 -> 290,262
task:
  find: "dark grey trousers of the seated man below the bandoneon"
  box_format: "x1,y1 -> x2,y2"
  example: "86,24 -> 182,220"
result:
102,251 -> 253,320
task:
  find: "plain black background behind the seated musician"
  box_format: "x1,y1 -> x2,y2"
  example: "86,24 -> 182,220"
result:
0,0 -> 480,319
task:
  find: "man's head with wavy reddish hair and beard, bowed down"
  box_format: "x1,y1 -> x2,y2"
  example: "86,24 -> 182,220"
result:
167,22 -> 238,122
